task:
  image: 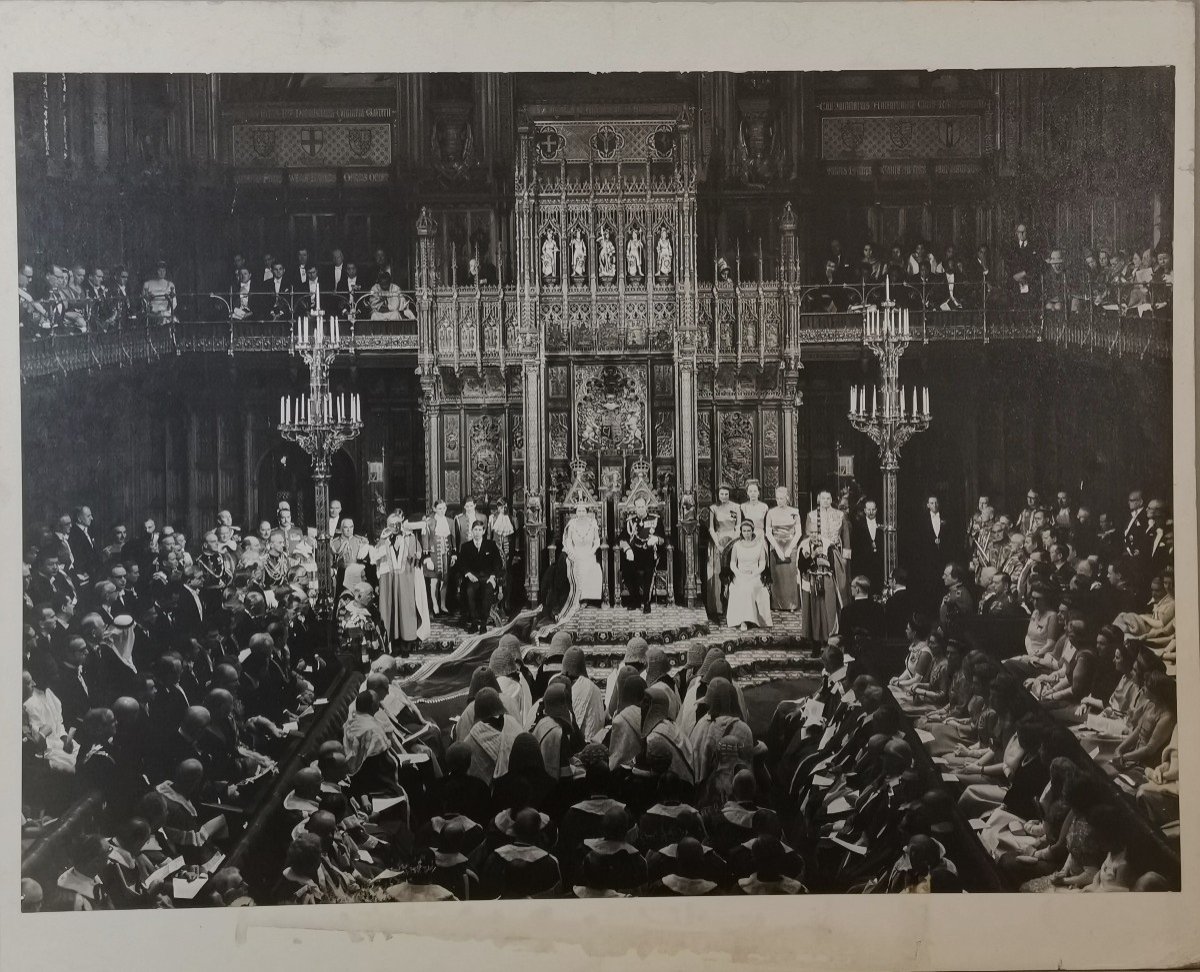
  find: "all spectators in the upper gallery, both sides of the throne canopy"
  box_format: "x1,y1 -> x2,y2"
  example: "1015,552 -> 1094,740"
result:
17,223 -> 1174,338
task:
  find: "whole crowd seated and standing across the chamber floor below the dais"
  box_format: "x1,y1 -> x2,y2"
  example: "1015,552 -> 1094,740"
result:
22,468 -> 1178,908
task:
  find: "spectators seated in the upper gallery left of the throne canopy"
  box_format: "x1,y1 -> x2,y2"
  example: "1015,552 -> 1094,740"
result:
17,250 -> 416,338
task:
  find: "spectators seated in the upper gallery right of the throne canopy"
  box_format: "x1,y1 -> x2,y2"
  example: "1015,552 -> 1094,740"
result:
804,223 -> 1174,318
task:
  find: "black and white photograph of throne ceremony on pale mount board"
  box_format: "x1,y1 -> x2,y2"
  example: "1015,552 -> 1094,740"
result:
0,4 -> 1200,968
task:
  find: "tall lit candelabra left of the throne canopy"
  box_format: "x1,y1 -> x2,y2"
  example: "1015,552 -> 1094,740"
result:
280,312 -> 362,623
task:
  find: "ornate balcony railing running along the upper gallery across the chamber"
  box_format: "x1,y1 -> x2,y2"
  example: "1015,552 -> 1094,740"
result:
20,282 -> 1171,379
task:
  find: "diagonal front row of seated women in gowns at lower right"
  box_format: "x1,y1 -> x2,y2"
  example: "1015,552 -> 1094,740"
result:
890,629 -> 1177,892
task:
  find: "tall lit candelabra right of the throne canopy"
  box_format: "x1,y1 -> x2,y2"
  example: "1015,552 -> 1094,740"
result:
850,295 -> 930,590
